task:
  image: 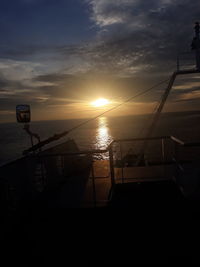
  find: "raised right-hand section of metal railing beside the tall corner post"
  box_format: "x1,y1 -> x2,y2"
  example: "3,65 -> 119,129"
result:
110,136 -> 176,183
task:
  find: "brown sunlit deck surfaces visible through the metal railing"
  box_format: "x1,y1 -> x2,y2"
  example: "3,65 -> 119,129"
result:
81,160 -> 173,207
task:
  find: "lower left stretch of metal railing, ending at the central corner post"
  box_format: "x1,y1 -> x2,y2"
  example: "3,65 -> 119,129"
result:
0,149 -> 114,212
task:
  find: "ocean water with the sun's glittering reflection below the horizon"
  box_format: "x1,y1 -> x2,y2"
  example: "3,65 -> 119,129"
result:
0,112 -> 200,165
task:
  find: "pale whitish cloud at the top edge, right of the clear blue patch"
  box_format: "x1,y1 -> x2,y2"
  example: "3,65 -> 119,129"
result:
87,0 -> 172,29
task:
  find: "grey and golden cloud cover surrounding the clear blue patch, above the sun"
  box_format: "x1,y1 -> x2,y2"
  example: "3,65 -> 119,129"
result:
0,0 -> 200,122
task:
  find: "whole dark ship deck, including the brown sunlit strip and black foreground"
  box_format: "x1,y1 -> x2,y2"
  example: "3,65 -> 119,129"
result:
1,149 -> 199,266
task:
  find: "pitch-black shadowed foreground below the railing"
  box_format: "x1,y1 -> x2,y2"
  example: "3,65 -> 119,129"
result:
1,178 -> 200,266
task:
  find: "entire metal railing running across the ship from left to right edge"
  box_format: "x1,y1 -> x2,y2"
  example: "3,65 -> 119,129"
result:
0,136 -> 200,211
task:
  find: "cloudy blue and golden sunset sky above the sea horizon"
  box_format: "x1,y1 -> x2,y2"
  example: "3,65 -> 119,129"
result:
0,0 -> 200,122
